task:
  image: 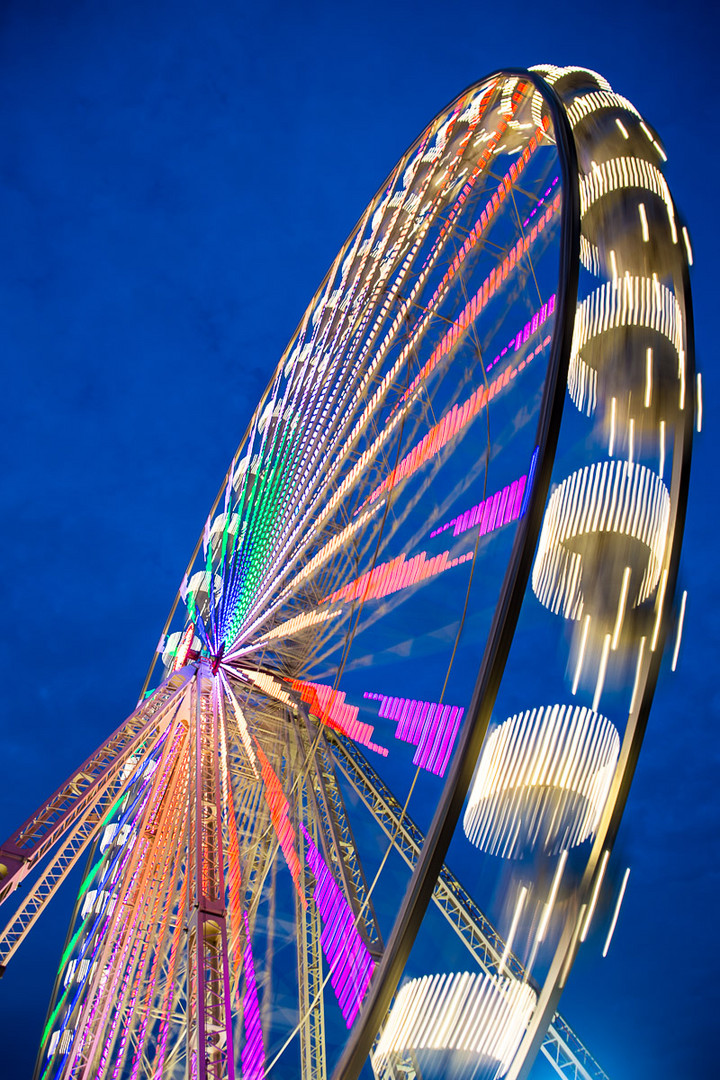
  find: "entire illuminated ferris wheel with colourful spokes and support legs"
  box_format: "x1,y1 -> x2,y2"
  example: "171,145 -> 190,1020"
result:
0,66 -> 702,1080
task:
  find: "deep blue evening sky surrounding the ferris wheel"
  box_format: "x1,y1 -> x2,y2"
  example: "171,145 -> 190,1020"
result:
0,0 -> 720,1080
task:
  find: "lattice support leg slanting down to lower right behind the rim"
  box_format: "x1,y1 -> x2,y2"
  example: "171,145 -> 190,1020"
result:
326,729 -> 608,1080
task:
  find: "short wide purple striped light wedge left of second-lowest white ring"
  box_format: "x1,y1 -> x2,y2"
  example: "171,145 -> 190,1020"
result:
363,693 -> 464,777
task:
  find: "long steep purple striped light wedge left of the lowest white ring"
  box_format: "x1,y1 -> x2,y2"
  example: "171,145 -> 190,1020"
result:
300,825 -> 375,1027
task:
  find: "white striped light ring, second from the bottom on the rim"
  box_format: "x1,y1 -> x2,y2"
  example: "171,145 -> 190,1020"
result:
463,705 -> 620,859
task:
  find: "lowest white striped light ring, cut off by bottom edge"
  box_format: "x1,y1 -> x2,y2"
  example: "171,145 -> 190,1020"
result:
372,972 -> 535,1080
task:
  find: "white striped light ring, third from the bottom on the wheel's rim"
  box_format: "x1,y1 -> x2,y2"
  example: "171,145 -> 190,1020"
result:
532,461 -> 670,619
